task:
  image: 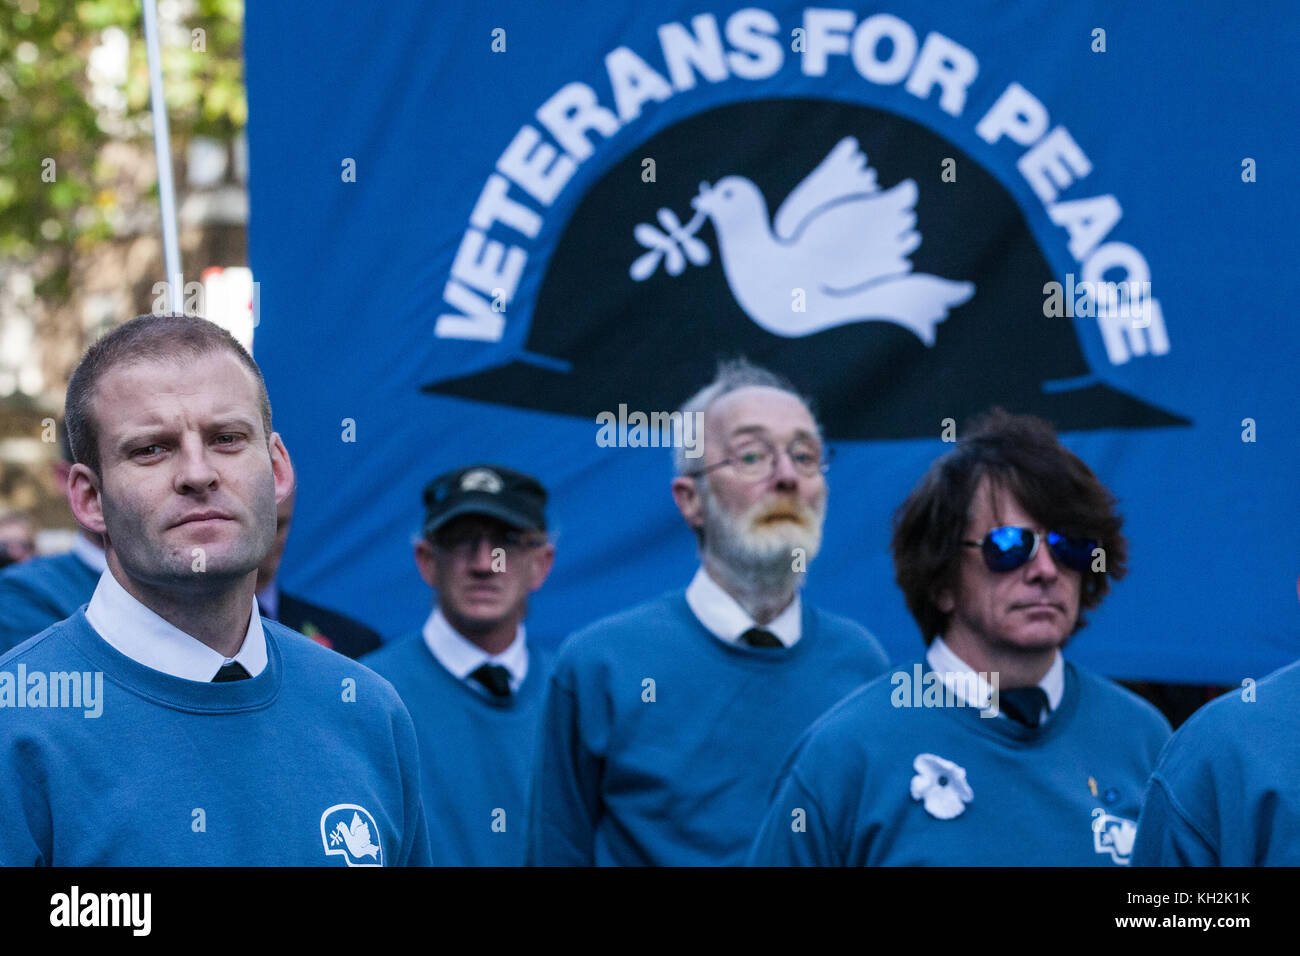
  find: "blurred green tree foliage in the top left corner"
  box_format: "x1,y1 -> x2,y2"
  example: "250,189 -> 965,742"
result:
0,0 -> 248,297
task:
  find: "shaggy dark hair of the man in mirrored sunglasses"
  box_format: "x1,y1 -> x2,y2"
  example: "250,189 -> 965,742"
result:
891,408 -> 1128,645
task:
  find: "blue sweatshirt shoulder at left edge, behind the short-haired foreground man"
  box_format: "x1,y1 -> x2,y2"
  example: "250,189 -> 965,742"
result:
0,551 -> 99,654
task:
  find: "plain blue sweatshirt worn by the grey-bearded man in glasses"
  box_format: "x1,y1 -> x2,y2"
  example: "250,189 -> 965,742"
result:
528,591 -> 887,866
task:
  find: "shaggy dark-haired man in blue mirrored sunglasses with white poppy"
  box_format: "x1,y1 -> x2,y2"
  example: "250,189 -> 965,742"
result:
750,410 -> 1170,866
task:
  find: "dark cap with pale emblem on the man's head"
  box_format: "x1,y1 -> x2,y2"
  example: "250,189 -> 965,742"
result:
424,464 -> 547,537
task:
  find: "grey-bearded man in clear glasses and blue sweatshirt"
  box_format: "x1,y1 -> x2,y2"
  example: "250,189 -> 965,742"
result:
528,359 -> 888,866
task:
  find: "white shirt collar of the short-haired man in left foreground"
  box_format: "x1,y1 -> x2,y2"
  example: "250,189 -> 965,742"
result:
86,570 -> 267,683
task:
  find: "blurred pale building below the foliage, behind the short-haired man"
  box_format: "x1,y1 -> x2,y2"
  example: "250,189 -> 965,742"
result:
0,3 -> 252,550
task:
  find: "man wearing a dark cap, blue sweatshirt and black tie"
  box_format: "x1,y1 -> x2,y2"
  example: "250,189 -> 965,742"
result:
363,464 -> 555,866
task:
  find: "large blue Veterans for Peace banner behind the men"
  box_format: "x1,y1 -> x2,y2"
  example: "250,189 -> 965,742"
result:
246,0 -> 1300,683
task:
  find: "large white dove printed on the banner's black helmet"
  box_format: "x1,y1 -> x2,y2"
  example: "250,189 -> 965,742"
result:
690,137 -> 975,346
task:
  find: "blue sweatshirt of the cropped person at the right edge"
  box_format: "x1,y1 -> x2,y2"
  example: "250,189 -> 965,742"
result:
1134,662 -> 1300,866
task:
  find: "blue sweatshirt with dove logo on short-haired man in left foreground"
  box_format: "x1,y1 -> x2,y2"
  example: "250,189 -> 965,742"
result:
0,611 -> 429,866
